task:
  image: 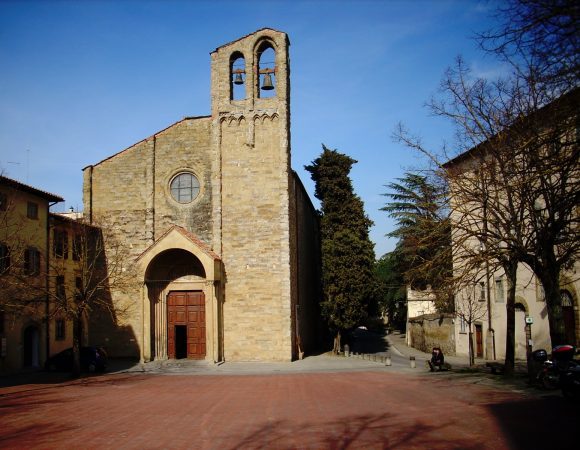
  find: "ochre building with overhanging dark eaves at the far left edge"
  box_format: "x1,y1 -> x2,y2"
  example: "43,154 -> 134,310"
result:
0,176 -> 70,373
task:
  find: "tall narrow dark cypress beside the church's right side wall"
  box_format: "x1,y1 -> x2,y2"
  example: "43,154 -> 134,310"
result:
305,145 -> 376,353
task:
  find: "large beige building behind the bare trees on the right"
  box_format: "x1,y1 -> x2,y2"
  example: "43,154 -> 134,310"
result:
445,90 -> 580,359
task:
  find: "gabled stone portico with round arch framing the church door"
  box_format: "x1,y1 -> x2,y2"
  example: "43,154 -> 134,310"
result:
138,226 -> 222,361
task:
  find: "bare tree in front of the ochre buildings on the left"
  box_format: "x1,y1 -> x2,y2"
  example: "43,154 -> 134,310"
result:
0,205 -> 136,375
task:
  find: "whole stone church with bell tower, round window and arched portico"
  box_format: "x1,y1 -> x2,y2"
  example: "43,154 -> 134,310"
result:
83,28 -> 321,362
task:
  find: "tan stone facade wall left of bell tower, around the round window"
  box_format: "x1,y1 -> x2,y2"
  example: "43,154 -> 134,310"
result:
84,118 -> 212,356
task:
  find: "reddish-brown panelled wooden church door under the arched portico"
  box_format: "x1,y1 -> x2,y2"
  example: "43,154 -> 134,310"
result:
167,291 -> 206,359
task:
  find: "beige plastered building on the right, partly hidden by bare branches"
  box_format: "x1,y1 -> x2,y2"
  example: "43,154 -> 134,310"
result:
445,92 -> 580,359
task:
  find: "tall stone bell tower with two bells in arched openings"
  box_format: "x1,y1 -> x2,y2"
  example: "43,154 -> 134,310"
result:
211,28 -> 295,360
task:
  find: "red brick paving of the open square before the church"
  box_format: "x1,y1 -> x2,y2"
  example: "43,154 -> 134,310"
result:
0,370 -> 578,449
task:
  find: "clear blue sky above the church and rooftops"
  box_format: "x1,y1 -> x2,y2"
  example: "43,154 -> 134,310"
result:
0,0 -> 497,257
